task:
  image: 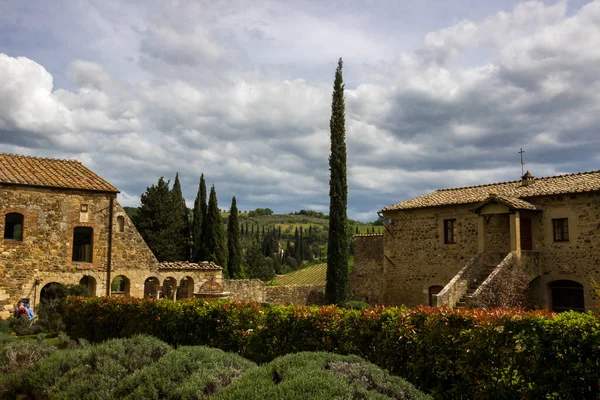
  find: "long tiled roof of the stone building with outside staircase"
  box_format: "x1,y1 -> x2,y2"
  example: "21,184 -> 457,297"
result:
380,171 -> 600,212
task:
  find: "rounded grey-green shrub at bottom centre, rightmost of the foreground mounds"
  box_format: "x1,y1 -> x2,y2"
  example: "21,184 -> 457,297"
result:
214,353 -> 430,400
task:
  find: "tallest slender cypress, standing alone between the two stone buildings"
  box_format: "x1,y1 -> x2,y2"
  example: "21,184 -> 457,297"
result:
325,58 -> 348,304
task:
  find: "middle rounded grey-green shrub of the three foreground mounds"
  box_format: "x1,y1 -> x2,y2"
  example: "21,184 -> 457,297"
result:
113,346 -> 256,400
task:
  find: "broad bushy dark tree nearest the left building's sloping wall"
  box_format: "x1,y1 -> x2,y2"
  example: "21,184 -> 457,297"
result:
133,177 -> 181,261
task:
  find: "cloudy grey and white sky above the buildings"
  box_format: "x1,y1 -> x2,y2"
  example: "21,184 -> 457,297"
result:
0,0 -> 600,220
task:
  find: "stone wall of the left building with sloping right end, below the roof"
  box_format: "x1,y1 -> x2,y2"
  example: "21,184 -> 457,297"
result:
0,185 -> 158,317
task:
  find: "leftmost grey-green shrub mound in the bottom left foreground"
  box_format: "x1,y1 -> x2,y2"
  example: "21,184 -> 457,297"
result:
1,336 -> 171,399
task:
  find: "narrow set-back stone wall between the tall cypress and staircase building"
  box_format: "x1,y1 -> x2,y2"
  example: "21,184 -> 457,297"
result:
348,233 -> 384,304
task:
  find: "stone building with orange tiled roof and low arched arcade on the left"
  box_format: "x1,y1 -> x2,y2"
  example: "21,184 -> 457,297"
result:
0,154 -> 223,317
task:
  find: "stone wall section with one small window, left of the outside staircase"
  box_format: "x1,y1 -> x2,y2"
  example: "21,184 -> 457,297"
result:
383,205 -> 478,306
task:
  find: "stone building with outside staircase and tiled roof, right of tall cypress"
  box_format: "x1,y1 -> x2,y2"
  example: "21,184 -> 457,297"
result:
366,171 -> 600,311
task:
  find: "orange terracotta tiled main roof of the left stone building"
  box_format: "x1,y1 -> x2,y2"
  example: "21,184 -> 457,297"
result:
0,154 -> 119,193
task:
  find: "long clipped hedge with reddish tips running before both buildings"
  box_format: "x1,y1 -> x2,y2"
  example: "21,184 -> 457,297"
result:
64,298 -> 600,399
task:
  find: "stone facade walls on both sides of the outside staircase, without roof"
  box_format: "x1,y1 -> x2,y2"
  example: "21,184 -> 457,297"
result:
383,193 -> 600,310
